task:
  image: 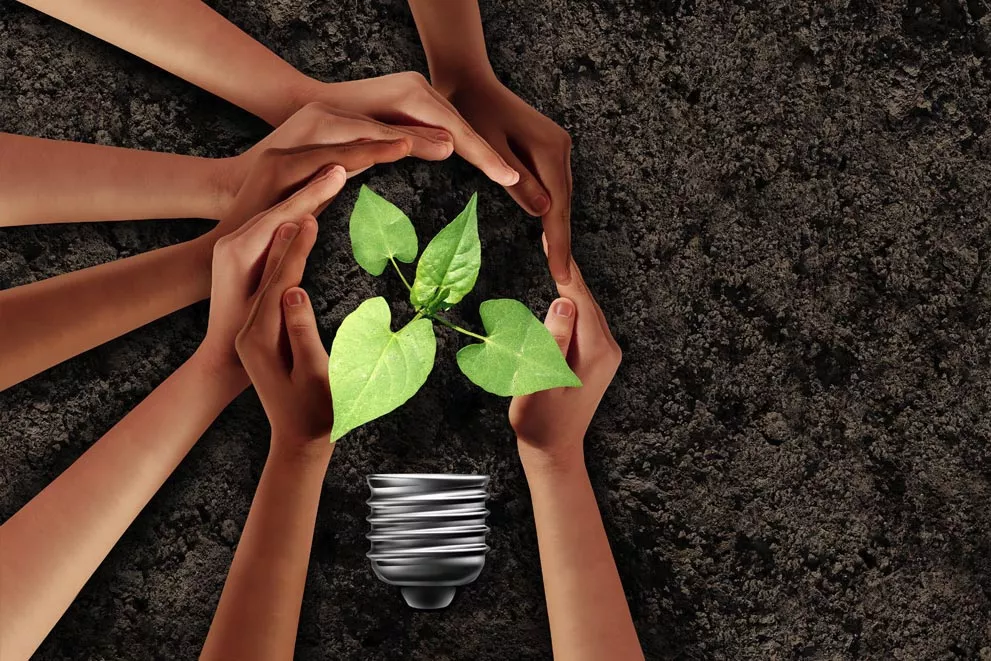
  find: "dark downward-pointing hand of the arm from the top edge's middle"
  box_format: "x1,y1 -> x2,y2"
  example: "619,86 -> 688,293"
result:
438,72 -> 571,284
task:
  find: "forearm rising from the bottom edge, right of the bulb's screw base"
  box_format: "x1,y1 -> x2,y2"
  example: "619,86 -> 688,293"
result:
520,445 -> 643,661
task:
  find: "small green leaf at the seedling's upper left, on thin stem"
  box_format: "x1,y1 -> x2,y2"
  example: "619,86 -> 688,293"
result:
350,185 -> 419,275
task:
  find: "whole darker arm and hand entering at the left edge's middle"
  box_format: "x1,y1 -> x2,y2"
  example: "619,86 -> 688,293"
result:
0,139 -> 410,390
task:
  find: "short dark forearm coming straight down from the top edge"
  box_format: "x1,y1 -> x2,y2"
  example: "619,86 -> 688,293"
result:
409,0 -> 492,93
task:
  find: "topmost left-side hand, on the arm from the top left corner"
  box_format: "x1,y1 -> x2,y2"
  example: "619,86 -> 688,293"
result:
294,71 -> 519,186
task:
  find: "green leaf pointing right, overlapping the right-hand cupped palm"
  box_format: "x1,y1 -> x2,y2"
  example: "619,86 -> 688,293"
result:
458,298 -> 582,397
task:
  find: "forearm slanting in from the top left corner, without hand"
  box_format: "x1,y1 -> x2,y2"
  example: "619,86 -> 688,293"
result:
21,0 -> 306,126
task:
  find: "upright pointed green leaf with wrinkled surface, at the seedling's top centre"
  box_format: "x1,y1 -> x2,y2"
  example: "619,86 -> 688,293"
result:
409,193 -> 482,312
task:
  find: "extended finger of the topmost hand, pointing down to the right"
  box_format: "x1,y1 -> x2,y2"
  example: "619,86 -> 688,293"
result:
402,86 -> 520,186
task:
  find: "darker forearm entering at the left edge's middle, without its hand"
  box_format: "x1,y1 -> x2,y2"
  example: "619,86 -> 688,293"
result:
0,233 -> 215,390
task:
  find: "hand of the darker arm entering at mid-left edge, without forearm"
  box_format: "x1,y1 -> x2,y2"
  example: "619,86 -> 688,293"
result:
212,139 -> 411,238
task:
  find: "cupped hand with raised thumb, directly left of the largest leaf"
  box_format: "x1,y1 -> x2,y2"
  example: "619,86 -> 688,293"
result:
236,280 -> 334,459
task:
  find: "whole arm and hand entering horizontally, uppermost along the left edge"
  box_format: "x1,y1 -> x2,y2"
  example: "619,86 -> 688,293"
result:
0,103 -> 453,226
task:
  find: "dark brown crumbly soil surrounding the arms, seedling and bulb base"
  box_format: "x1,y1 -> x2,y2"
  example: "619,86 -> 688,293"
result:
0,0 -> 991,661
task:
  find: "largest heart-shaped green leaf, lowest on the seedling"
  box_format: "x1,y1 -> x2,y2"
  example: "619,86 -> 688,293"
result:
328,296 -> 437,442
